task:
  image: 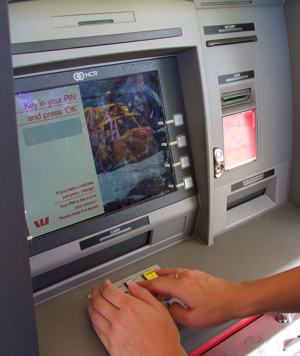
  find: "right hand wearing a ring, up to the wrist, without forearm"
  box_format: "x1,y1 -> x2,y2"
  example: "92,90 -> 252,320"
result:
139,268 -> 243,328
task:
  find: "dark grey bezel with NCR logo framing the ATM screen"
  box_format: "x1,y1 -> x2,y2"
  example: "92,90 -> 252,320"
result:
15,56 -> 196,256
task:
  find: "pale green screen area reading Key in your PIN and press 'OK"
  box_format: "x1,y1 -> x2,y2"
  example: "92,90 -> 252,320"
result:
16,85 -> 104,237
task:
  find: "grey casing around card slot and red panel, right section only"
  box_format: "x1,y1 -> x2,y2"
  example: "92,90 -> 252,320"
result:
192,1 -> 293,244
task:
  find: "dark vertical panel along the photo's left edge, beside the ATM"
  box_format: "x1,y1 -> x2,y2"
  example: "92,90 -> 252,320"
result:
0,0 -> 38,356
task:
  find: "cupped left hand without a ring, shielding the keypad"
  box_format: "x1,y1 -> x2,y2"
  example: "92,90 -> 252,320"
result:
88,280 -> 186,356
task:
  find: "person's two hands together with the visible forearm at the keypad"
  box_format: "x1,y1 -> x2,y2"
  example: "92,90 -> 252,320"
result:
88,267 -> 300,356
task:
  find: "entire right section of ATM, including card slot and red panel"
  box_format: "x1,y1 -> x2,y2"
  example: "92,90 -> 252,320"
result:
195,0 -> 292,244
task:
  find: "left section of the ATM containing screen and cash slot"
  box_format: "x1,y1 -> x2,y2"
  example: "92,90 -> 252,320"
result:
10,1 -> 205,301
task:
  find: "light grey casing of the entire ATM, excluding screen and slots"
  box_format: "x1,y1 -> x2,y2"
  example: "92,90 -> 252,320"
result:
9,0 -> 292,300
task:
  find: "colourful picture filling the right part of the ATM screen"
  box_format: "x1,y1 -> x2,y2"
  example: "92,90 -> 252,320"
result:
80,71 -> 175,212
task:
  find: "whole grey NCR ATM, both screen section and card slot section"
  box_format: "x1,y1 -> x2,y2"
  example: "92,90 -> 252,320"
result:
5,0 -> 298,355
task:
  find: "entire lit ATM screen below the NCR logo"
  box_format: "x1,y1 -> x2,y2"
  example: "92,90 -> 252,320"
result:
16,70 -> 176,237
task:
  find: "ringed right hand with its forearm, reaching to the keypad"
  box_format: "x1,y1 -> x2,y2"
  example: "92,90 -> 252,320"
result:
141,267 -> 300,328
